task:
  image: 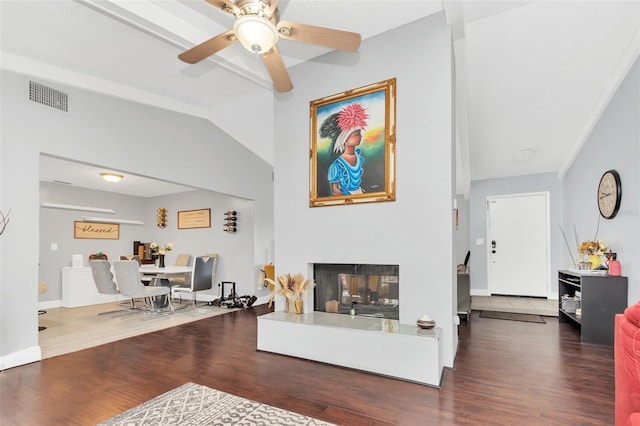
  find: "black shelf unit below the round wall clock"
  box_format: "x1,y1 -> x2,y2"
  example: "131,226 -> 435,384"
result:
558,271 -> 628,346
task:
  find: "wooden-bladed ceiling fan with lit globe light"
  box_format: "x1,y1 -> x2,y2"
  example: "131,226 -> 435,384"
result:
178,0 -> 360,92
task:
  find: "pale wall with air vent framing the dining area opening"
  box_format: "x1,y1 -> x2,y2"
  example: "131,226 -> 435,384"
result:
0,71 -> 273,368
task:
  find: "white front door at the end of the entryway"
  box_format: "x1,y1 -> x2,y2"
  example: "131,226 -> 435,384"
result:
487,193 -> 549,297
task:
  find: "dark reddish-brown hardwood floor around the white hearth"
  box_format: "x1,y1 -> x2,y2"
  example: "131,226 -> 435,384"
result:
0,305 -> 614,426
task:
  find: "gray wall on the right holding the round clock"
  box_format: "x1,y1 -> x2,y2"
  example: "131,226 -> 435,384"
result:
562,56 -> 640,304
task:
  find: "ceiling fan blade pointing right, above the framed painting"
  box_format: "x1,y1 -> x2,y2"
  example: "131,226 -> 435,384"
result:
278,21 -> 361,52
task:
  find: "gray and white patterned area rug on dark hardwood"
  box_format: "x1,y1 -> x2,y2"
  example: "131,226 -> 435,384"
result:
98,382 -> 335,426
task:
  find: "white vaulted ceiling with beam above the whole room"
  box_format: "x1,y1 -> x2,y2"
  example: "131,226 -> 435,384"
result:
0,0 -> 640,197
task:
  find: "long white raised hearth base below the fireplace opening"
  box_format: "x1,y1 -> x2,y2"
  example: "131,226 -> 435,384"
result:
258,311 -> 443,387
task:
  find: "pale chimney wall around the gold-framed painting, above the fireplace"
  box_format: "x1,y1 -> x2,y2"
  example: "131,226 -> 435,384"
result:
274,14 -> 457,366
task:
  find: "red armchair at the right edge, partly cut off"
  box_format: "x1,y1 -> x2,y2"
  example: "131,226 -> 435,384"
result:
613,303 -> 640,426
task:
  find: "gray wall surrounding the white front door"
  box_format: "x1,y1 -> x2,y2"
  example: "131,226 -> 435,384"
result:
469,173 -> 564,298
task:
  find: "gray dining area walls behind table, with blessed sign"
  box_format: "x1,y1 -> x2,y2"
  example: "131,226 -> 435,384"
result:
39,182 -> 268,309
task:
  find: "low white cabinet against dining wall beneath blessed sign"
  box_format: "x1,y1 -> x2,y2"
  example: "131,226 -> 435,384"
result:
62,266 -> 117,308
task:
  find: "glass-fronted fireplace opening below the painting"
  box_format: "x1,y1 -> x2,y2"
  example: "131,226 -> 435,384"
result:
313,263 -> 400,319
